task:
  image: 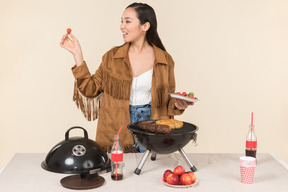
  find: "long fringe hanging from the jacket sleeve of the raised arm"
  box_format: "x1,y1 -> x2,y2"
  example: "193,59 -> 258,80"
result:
73,80 -> 103,121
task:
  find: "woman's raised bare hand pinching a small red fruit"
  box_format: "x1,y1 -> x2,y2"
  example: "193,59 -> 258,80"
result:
60,33 -> 83,66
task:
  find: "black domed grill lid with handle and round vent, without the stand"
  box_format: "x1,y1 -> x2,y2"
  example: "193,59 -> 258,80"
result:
41,126 -> 110,174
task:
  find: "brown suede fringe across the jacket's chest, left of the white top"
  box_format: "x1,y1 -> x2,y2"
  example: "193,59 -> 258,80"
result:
103,72 -> 132,100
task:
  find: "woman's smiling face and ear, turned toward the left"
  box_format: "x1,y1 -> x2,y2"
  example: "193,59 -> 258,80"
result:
120,8 -> 150,43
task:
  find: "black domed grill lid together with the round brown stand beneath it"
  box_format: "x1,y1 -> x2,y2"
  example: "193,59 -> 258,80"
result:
41,126 -> 111,189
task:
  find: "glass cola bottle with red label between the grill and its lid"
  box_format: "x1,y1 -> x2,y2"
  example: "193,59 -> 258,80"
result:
111,135 -> 124,181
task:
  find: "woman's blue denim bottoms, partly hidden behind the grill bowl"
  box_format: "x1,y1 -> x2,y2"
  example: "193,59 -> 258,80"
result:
129,104 -> 151,153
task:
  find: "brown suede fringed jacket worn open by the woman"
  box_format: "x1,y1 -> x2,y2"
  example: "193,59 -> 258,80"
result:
72,43 -> 184,152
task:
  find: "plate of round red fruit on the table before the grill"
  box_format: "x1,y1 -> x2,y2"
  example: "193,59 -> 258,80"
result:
161,165 -> 198,188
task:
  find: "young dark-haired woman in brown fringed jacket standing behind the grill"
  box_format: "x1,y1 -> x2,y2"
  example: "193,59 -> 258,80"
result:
60,3 -> 193,152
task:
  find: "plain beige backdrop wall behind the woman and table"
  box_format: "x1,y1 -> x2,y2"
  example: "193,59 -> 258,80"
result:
0,0 -> 288,170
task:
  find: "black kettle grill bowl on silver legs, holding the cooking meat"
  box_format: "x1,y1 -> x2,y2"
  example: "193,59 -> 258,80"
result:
128,120 -> 198,175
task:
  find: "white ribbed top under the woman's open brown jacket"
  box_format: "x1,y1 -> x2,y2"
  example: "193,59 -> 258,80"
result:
130,68 -> 153,105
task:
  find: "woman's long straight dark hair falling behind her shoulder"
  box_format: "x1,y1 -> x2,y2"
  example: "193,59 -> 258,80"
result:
126,3 -> 166,51
